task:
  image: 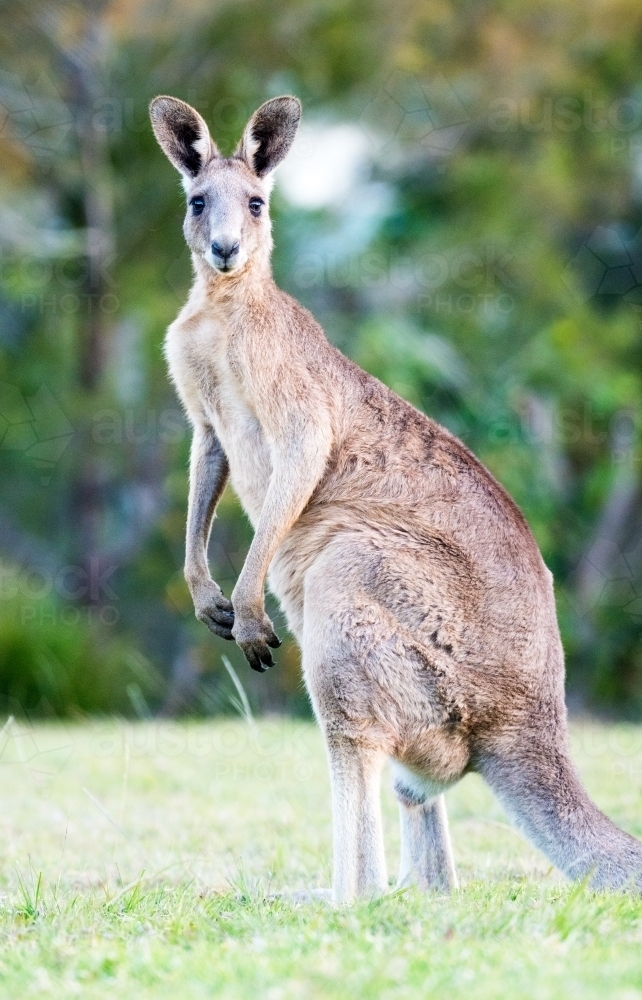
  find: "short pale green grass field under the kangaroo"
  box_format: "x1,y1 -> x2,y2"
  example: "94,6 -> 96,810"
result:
0,720 -> 642,1000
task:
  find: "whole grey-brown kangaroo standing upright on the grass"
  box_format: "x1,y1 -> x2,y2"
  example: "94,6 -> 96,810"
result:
150,96 -> 642,903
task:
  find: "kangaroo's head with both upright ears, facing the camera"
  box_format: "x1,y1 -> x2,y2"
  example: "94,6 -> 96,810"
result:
149,97 -> 301,275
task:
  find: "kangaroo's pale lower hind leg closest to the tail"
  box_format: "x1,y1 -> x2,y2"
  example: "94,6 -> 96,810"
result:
392,761 -> 457,892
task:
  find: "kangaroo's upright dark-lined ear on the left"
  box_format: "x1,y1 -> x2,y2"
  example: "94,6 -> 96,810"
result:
149,97 -> 218,180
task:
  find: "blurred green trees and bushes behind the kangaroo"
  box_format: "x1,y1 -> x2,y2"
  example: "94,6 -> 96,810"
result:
0,0 -> 642,719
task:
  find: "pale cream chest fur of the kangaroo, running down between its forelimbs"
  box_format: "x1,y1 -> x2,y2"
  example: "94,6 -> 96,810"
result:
165,319 -> 272,524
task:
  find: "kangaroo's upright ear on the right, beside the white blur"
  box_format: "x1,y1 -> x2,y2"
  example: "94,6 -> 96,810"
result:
234,97 -> 301,177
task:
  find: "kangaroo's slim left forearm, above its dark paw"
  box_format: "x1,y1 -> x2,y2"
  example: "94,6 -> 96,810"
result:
185,425 -> 229,583
